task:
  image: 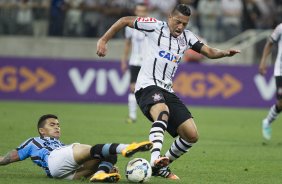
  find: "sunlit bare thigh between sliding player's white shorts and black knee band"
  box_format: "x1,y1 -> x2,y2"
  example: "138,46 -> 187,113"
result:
73,144 -> 92,164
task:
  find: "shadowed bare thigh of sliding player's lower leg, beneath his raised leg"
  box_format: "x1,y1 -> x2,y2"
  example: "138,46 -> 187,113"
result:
73,159 -> 100,179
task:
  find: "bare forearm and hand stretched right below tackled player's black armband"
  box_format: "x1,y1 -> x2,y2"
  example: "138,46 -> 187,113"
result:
201,45 -> 240,59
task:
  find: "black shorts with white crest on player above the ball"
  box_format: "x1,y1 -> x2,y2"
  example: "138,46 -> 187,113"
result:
135,86 -> 192,137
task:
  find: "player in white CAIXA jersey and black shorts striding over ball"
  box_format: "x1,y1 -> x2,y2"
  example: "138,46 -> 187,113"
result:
97,4 -> 240,179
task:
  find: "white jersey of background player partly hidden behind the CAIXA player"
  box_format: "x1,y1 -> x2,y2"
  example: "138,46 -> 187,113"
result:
125,27 -> 147,66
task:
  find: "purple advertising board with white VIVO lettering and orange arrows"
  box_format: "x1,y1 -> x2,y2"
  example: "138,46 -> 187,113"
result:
0,57 -> 275,107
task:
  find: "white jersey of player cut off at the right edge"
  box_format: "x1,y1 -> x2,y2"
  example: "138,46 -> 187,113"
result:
271,23 -> 282,76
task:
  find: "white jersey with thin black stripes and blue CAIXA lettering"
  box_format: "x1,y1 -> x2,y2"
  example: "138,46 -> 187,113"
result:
134,18 -> 202,92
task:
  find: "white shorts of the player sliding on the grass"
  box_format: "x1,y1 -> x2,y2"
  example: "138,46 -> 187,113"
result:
48,143 -> 80,180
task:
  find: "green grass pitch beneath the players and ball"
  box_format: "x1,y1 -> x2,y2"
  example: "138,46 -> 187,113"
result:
0,101 -> 282,184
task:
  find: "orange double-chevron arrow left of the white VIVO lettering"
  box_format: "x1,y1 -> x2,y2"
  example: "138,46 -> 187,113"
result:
19,67 -> 56,93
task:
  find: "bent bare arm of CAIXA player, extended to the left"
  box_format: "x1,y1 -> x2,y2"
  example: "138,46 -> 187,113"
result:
97,16 -> 137,57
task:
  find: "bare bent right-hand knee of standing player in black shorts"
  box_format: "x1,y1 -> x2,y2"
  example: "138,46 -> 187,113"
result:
177,118 -> 199,143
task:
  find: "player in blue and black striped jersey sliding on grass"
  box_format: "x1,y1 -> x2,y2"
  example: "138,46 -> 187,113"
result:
0,114 -> 153,182
